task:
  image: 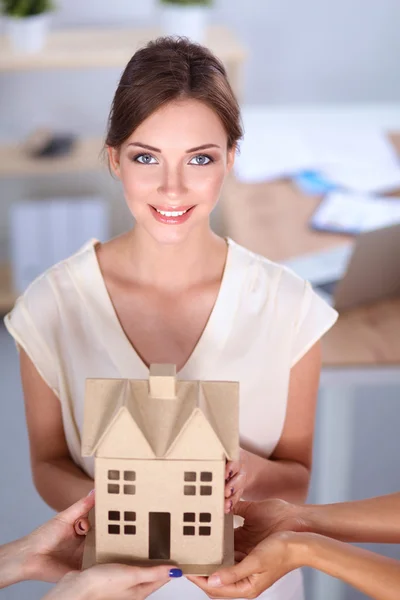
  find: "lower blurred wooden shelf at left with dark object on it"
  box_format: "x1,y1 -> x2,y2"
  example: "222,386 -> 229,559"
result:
0,138 -> 106,178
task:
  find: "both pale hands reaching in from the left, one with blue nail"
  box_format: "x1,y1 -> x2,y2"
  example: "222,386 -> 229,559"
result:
0,494 -> 182,600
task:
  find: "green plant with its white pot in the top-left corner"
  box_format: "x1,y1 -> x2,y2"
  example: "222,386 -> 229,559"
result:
0,0 -> 54,53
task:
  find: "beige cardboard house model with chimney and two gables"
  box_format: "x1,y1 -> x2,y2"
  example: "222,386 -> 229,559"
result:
82,365 -> 239,575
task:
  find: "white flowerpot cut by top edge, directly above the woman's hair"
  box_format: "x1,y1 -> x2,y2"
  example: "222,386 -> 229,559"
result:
161,0 -> 213,43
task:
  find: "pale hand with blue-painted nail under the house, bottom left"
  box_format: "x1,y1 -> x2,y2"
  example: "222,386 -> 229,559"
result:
43,565 -> 178,600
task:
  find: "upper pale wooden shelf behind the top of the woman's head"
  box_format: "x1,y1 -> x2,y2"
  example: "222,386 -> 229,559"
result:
0,27 -> 246,71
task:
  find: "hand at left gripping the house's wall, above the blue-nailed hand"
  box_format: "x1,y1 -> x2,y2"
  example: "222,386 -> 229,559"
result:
21,494 -> 94,583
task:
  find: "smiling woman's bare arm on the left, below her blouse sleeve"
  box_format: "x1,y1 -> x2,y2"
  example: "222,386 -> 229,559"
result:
20,348 -> 93,511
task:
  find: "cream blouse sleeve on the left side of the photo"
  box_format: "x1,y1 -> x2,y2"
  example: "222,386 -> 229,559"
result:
4,276 -> 59,397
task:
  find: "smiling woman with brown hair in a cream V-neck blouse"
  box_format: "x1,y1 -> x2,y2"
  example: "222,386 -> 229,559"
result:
5,38 -> 337,600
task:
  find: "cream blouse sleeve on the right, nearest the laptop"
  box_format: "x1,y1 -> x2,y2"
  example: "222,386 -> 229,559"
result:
291,281 -> 338,367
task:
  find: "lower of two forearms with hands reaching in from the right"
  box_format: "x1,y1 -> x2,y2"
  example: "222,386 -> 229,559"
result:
193,532 -> 400,600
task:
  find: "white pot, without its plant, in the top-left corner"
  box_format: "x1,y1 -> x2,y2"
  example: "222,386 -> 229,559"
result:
5,13 -> 50,54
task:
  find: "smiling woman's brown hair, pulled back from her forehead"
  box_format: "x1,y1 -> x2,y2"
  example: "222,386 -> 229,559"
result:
105,37 -> 243,149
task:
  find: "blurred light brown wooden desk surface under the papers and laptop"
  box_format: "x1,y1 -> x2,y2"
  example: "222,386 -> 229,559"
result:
221,168 -> 400,368
